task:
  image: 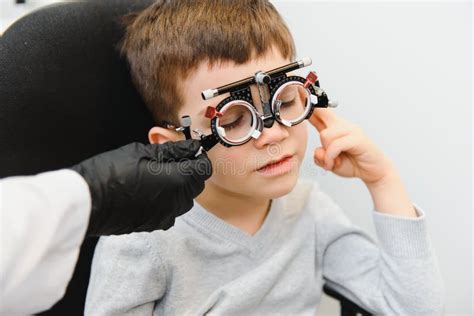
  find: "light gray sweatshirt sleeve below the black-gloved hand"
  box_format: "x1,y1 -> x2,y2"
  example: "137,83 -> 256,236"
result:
85,232 -> 166,316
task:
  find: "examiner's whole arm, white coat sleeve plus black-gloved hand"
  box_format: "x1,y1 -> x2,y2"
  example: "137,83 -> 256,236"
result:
0,140 -> 212,315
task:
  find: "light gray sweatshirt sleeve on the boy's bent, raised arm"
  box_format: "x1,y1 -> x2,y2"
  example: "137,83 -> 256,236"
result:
311,186 -> 444,316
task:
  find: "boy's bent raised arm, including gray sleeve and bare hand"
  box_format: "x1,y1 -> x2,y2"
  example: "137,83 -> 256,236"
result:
309,108 -> 443,315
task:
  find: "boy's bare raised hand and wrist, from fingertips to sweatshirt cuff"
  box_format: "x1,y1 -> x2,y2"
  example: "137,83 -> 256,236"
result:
309,108 -> 417,217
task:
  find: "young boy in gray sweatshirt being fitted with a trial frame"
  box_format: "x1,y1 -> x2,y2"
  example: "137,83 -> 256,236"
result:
86,0 -> 443,315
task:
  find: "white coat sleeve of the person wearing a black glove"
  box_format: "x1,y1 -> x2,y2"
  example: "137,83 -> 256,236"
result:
0,169 -> 91,315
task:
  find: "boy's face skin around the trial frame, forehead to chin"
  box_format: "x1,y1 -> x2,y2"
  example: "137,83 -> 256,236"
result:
151,50 -> 308,199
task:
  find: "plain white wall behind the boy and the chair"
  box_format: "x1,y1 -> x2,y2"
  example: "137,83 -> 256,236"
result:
0,0 -> 474,315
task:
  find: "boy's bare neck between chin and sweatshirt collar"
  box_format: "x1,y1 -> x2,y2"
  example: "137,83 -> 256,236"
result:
196,183 -> 271,235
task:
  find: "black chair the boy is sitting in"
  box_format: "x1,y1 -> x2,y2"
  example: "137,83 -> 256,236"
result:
0,0 -> 370,315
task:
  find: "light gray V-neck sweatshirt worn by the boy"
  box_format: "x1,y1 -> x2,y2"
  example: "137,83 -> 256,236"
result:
86,180 -> 444,316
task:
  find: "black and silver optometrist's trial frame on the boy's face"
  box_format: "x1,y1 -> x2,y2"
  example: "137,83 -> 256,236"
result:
164,57 -> 338,151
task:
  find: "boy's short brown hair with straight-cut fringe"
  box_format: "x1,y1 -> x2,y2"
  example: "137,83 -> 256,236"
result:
119,0 -> 296,125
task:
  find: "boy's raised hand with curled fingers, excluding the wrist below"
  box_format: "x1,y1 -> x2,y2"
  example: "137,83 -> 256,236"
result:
309,108 -> 395,185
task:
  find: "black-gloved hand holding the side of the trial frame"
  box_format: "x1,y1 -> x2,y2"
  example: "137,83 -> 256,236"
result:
71,140 -> 212,236
